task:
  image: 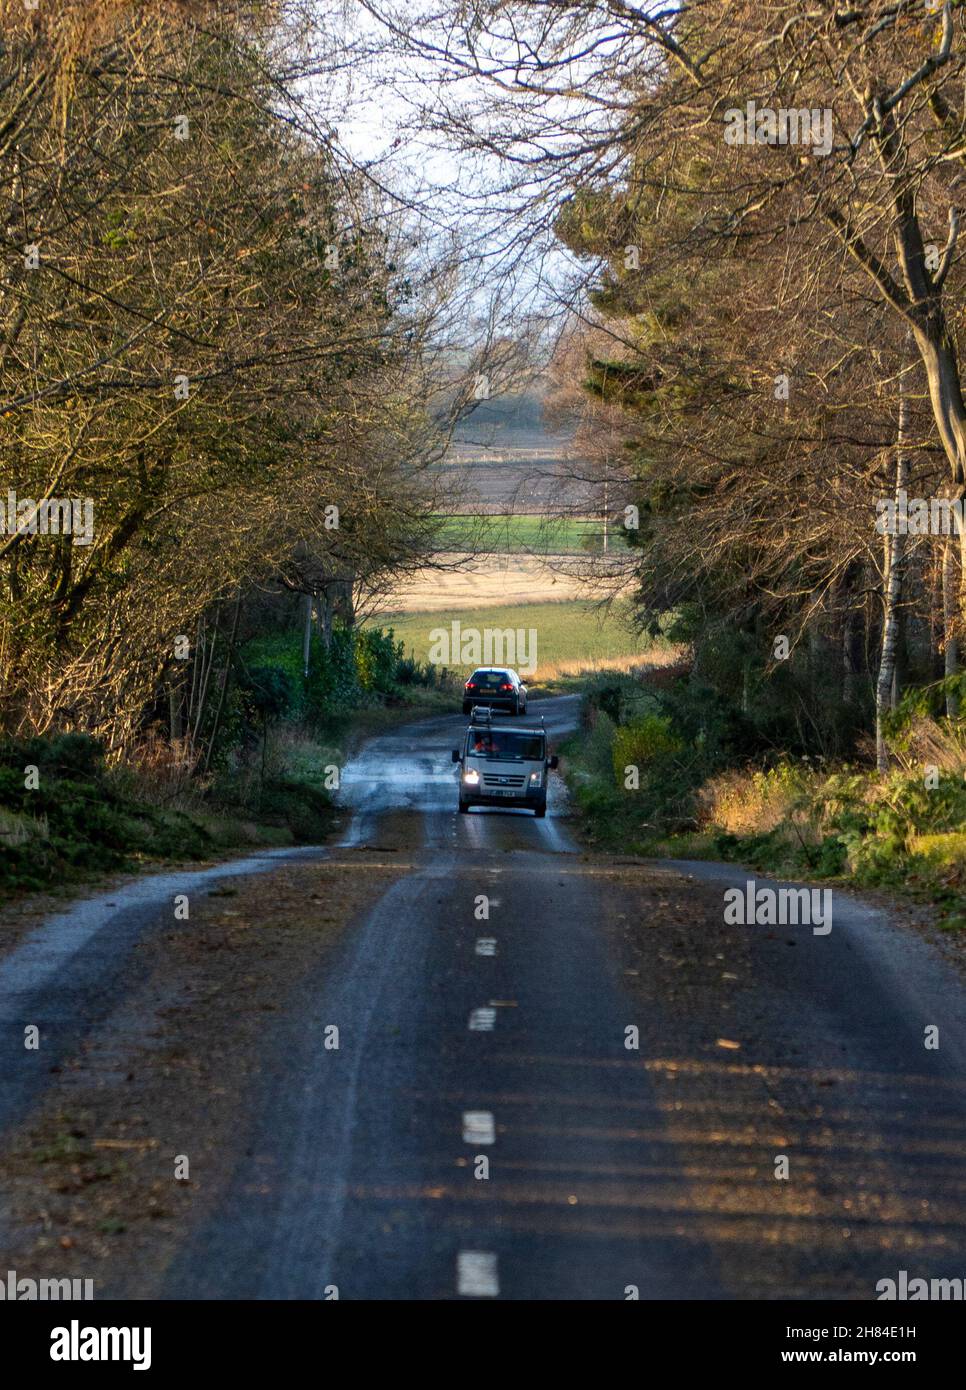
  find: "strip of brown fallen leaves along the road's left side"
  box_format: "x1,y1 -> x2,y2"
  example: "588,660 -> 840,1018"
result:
0,847 -> 408,1298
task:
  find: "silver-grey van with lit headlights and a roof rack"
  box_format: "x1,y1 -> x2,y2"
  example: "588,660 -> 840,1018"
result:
453,706 -> 557,816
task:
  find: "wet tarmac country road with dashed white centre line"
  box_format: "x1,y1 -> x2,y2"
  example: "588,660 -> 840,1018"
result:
0,698 -> 966,1300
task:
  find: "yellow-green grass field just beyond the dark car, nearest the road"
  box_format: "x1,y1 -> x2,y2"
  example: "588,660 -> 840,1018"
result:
377,602 -> 655,677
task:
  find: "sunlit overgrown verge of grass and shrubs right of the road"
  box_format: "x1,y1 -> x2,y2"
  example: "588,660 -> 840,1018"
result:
563,673 -> 966,931
